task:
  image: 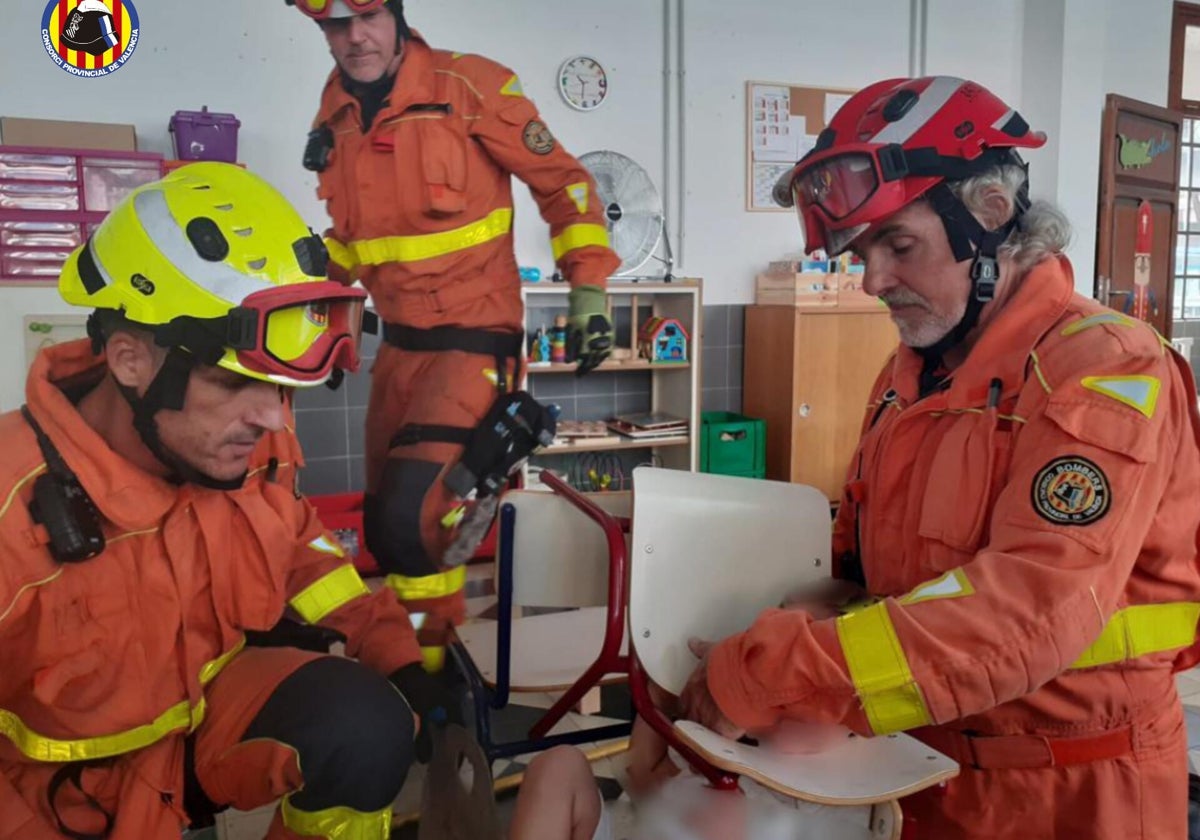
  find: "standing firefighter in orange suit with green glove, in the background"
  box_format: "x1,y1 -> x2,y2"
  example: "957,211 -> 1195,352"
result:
288,0 -> 619,670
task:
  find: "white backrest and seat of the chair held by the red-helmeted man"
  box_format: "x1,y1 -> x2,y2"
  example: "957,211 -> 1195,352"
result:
629,467 -> 958,816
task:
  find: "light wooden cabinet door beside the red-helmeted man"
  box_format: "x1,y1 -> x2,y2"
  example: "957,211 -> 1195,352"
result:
791,310 -> 898,500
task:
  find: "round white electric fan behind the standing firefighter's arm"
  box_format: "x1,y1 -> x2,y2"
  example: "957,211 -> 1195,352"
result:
580,151 -> 674,283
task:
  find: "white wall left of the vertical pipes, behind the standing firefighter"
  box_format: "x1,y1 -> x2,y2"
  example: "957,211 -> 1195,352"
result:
0,0 -> 664,410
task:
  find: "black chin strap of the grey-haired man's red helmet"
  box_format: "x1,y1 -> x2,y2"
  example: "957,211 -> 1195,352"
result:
914,181 -> 1028,394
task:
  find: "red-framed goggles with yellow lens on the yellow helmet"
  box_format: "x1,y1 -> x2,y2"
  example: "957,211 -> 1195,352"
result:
222,281 -> 367,385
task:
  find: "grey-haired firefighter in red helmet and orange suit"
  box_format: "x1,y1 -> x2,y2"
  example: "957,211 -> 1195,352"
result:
684,77 -> 1200,840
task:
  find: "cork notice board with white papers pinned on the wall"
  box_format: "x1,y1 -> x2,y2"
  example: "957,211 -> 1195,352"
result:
745,82 -> 854,212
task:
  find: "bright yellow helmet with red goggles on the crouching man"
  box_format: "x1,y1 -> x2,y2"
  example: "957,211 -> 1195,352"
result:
59,162 -> 366,386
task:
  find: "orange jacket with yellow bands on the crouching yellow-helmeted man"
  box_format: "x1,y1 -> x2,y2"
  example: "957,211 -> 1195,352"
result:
0,341 -> 420,840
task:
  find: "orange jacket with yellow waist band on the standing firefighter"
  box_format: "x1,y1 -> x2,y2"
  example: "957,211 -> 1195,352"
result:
316,34 -> 620,330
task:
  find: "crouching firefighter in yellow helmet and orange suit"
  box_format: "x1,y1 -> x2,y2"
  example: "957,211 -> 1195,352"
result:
0,163 -> 450,840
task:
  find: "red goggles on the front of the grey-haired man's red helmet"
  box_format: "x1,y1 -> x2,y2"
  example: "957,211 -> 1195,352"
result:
775,143 -> 936,257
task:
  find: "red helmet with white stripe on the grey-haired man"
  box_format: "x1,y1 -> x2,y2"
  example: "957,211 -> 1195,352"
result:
774,76 -> 1046,256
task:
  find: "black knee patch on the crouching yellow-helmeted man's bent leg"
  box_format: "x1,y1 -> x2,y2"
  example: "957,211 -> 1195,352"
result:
242,656 -> 416,812
